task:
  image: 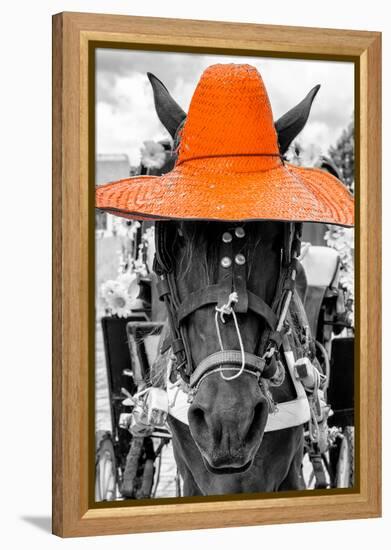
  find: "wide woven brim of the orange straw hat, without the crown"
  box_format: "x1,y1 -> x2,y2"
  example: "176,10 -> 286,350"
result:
96,163 -> 354,226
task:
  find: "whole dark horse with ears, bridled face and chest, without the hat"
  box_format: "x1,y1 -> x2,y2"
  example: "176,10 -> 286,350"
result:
148,74 -> 319,496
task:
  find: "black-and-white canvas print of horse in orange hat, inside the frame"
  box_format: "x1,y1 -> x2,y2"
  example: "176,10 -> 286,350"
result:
95,48 -> 355,504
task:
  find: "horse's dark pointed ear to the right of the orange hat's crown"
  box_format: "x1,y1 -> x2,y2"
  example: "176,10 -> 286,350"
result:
274,84 -> 320,155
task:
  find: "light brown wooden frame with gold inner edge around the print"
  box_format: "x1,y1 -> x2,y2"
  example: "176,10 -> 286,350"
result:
53,13 -> 381,537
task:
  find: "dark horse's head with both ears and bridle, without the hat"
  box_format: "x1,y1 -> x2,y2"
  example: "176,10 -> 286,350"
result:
148,69 -> 319,474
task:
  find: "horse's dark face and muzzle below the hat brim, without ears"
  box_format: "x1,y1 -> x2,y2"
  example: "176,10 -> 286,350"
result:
167,222 -> 290,473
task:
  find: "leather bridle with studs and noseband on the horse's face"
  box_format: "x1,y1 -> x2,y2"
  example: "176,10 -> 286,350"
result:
154,221 -> 302,406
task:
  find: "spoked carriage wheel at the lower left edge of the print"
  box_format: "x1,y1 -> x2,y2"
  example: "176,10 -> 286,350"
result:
95,432 -> 117,502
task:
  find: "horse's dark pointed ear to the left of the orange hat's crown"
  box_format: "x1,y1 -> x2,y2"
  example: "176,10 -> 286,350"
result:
147,73 -> 186,138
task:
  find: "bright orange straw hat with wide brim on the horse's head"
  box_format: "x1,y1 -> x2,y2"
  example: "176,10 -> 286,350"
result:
96,64 -> 354,226
